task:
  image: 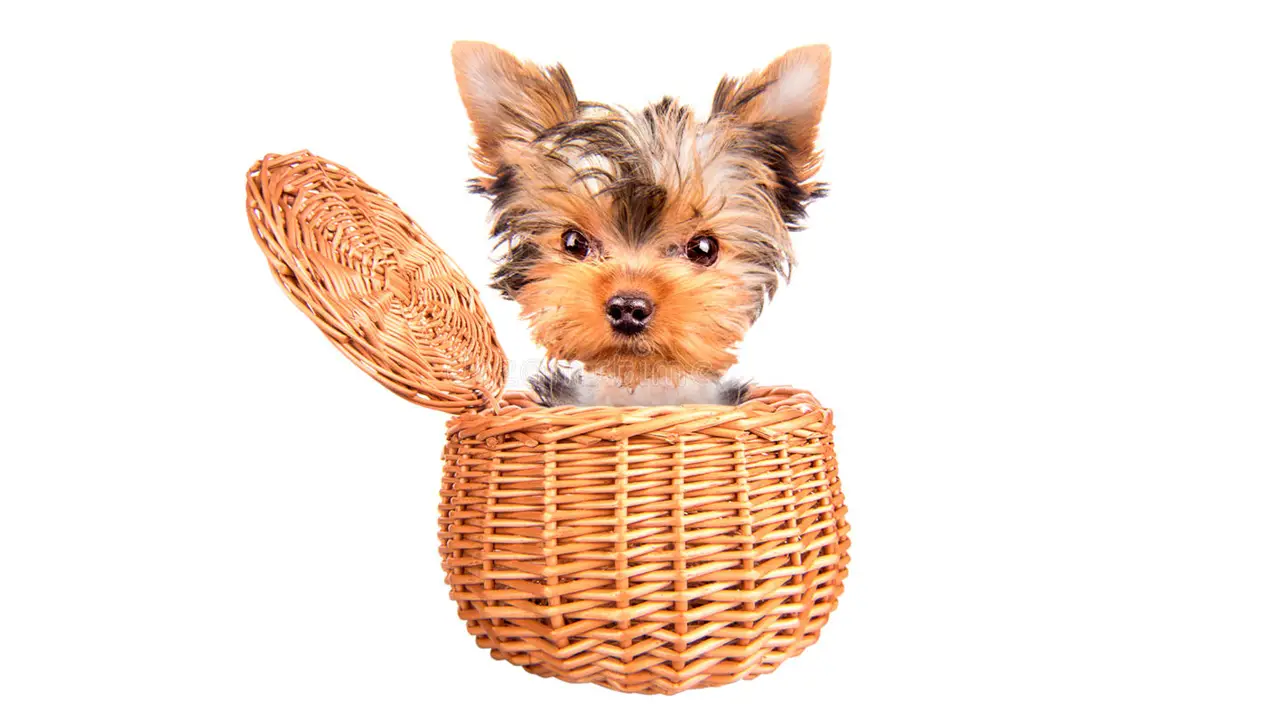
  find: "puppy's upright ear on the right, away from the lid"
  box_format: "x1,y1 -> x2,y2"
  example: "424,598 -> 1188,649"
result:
712,45 -> 831,177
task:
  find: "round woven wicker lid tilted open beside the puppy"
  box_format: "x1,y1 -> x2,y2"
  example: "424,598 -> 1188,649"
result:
247,150 -> 507,414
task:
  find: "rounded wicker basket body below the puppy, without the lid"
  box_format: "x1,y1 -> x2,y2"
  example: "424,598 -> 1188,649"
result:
439,388 -> 849,694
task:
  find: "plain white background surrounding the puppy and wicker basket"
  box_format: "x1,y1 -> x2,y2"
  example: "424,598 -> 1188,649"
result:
0,1 -> 1280,719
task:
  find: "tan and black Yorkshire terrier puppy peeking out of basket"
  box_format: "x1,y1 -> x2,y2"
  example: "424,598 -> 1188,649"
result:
453,42 -> 831,405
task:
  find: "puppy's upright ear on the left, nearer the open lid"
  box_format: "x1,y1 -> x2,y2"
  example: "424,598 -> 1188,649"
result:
453,42 -> 577,174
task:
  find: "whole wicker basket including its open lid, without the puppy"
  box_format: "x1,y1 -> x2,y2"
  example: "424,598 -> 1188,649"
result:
248,151 -> 849,694
